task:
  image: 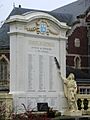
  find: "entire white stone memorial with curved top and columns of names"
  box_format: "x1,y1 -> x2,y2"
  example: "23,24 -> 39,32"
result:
7,12 -> 68,113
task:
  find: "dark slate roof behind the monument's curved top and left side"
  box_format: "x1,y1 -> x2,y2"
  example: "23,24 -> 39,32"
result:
0,7 -> 72,49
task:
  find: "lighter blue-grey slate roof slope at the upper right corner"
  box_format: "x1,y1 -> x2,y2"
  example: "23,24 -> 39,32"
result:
53,0 -> 90,24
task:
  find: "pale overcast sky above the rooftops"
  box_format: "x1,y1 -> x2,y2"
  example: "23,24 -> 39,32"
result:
0,0 -> 76,22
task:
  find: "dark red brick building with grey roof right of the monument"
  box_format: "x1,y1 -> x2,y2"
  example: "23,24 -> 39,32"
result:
54,0 -> 90,93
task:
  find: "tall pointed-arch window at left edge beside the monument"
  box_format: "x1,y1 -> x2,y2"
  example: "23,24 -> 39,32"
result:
0,55 -> 9,81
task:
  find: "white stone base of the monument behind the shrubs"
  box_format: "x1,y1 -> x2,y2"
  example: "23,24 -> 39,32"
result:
12,91 -> 66,113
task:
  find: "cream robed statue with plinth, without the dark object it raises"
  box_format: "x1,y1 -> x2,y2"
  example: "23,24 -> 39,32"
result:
59,70 -> 82,116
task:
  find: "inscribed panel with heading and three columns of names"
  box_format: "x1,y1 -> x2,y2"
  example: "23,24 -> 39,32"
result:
28,41 -> 55,92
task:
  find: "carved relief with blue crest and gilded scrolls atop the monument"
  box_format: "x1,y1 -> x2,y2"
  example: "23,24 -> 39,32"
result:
25,19 -> 60,36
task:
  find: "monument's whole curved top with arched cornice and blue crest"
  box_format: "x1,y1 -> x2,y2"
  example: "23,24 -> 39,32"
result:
8,12 -> 69,37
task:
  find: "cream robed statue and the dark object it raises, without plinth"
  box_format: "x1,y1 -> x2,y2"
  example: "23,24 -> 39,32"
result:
54,57 -> 78,115
